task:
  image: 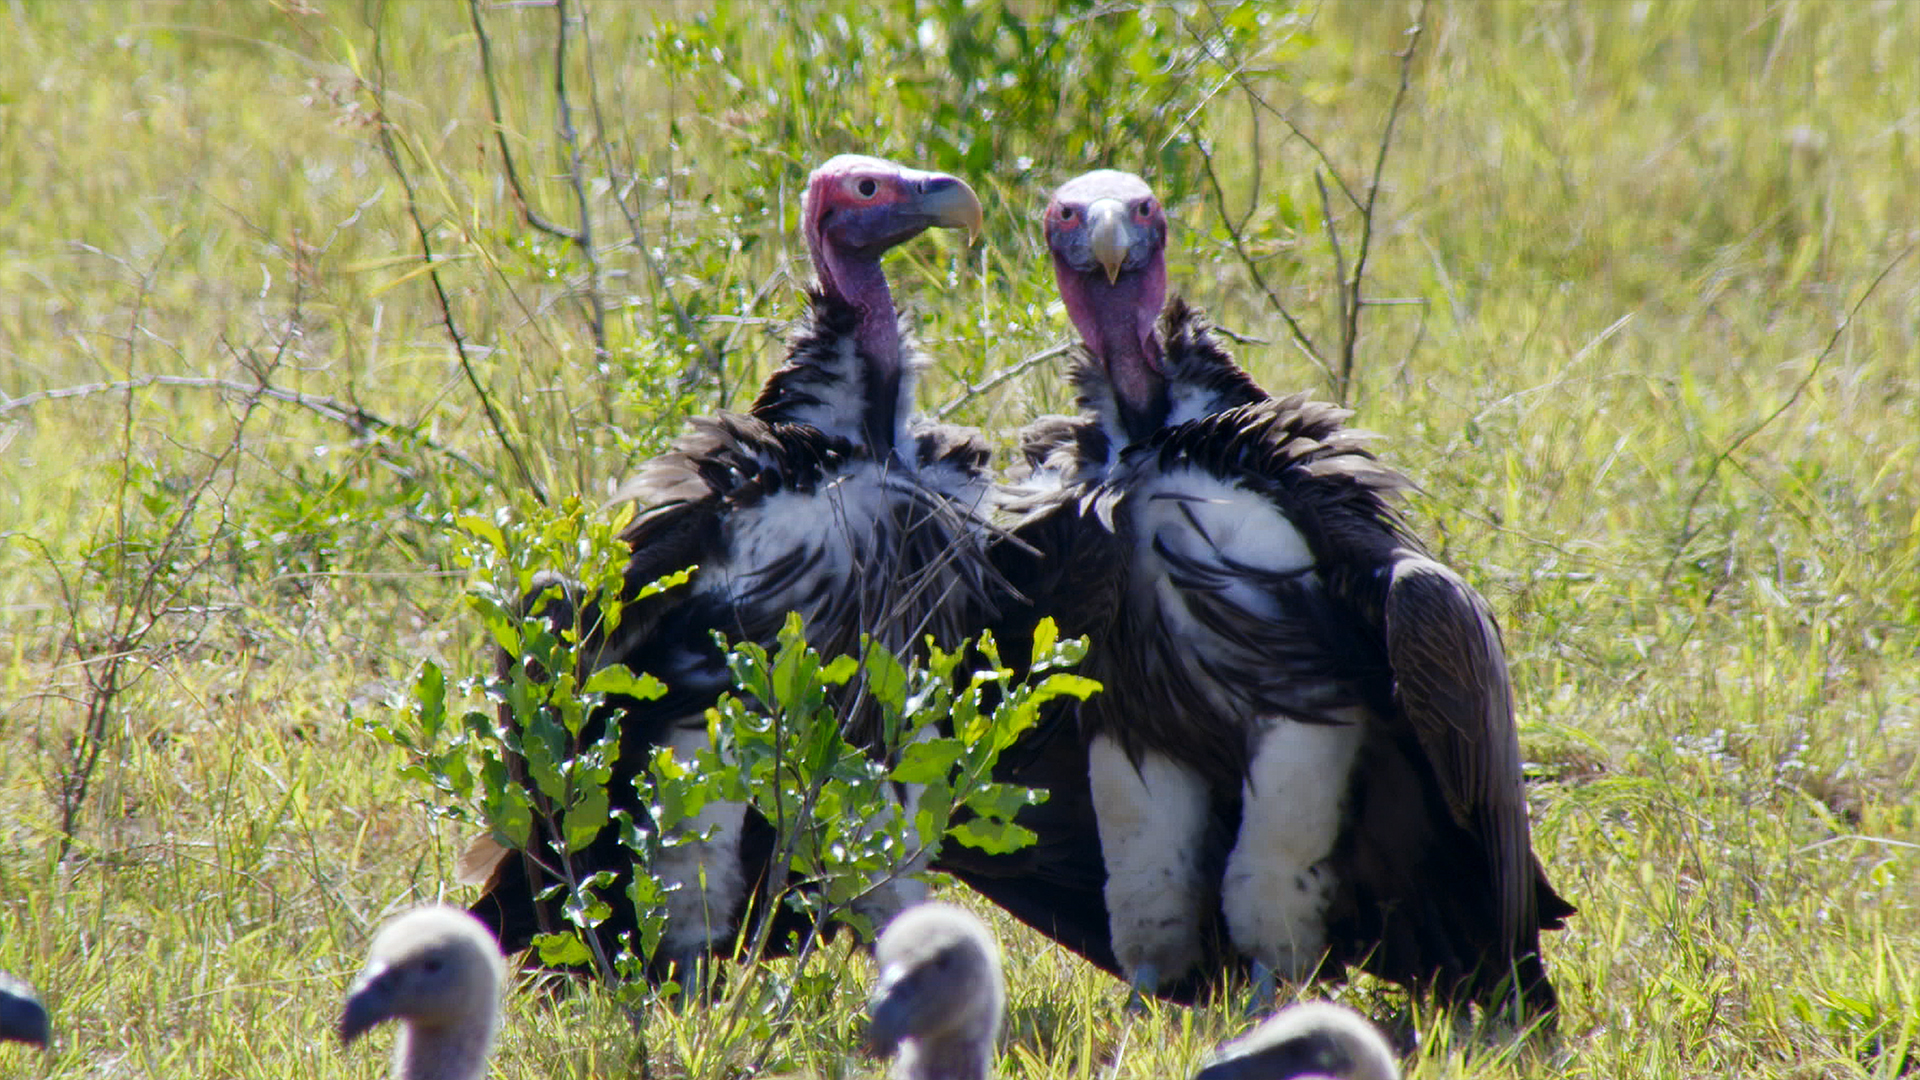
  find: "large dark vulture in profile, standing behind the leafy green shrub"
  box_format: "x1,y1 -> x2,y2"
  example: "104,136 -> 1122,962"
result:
463,156 -> 1004,972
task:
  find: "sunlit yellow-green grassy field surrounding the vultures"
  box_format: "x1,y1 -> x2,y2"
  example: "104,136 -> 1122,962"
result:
0,0 -> 1920,1080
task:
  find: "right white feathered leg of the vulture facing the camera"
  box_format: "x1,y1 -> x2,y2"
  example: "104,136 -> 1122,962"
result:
1221,709 -> 1365,982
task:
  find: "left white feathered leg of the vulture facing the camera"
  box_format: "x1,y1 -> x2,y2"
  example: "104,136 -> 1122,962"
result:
1087,734 -> 1212,994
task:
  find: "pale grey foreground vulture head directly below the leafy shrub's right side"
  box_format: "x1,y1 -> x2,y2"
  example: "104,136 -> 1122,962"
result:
866,903 -> 1006,1080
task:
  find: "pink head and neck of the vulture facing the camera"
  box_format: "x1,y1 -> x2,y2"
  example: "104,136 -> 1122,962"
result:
1044,169 -> 1167,438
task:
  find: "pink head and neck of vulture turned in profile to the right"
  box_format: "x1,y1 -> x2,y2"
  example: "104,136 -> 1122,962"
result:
801,154 -> 981,363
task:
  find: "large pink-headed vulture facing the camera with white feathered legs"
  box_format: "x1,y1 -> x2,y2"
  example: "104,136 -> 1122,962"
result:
1010,171 -> 1572,1015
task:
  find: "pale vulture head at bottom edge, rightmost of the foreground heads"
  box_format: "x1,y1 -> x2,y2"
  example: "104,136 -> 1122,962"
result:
1194,1001 -> 1400,1080
